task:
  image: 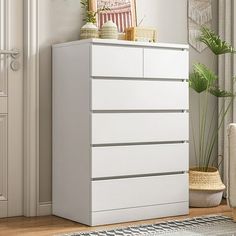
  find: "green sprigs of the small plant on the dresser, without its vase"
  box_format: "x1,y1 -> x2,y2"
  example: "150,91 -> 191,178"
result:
80,0 -> 110,24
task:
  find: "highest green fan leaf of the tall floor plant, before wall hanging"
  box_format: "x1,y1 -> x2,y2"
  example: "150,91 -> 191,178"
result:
199,26 -> 236,55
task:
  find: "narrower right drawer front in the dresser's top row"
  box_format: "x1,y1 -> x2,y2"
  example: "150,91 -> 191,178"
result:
144,49 -> 189,79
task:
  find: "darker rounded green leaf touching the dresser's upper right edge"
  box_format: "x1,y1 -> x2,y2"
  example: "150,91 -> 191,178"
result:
189,72 -> 208,93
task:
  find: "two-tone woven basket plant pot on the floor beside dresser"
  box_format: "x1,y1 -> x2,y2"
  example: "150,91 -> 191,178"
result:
189,167 -> 225,207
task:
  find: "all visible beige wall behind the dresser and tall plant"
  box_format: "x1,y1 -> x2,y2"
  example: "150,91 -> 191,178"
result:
39,0 -> 217,202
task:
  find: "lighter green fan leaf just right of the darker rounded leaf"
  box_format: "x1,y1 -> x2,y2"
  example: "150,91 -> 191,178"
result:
193,63 -> 218,87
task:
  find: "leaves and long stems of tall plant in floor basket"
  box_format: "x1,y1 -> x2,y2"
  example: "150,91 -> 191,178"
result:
189,27 -> 236,171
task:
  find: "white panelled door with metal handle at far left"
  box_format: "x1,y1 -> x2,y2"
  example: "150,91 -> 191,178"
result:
0,0 -> 23,217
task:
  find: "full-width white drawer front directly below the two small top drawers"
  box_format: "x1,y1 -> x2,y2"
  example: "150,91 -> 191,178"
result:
92,79 -> 189,110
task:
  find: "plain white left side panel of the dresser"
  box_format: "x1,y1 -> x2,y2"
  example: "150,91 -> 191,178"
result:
53,44 -> 91,224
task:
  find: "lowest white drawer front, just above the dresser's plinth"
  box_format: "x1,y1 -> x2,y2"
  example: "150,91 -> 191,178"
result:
92,174 -> 188,211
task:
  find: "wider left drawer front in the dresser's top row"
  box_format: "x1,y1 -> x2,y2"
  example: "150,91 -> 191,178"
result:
91,45 -> 143,77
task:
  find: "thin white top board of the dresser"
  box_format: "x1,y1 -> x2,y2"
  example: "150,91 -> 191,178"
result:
53,39 -> 189,50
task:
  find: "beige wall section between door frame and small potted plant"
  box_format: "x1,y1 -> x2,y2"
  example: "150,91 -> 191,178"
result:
39,0 -> 83,202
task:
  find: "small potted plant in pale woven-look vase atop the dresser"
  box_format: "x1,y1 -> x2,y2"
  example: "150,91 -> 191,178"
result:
80,0 -> 109,39
